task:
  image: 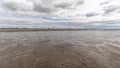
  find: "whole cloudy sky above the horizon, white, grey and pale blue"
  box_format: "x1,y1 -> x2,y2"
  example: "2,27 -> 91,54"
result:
0,0 -> 120,28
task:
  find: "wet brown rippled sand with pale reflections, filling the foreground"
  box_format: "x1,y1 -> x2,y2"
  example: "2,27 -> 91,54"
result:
0,30 -> 120,68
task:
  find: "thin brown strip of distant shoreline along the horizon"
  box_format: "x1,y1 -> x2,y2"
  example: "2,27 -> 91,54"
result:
0,28 -> 120,32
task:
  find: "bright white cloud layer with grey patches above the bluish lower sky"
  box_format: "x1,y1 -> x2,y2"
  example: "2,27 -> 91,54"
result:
0,0 -> 120,27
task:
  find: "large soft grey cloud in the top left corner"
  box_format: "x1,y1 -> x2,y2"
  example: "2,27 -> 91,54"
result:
1,0 -> 33,11
